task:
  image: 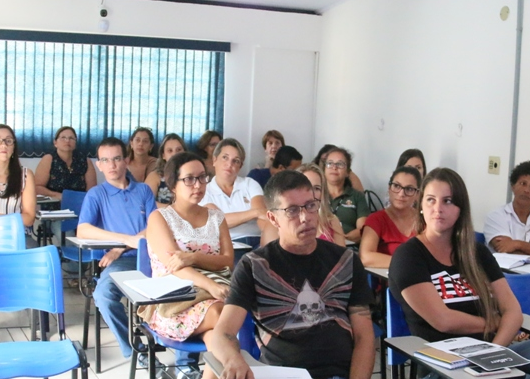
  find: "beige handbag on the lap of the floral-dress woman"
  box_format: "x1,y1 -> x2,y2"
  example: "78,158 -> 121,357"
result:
137,266 -> 232,322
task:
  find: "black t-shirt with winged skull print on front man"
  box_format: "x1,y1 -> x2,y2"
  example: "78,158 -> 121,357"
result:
226,240 -> 373,379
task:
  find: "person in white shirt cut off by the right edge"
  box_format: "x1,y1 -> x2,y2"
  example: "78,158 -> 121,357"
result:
484,161 -> 530,254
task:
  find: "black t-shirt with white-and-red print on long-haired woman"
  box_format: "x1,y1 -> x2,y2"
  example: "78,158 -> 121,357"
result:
388,238 -> 504,342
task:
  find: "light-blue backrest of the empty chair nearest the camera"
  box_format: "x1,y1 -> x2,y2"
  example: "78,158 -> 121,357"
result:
0,245 -> 64,313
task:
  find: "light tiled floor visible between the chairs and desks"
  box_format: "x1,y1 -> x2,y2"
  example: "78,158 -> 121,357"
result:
0,288 -> 390,379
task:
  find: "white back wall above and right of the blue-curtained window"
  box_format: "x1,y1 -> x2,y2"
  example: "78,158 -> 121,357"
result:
0,0 -> 322,174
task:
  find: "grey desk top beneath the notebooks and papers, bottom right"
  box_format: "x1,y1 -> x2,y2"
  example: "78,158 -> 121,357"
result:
385,336 -> 525,379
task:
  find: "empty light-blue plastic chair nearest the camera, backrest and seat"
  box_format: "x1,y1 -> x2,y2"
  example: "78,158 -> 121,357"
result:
0,246 -> 89,379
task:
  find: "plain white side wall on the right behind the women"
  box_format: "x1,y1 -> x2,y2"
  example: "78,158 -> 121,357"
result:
315,0 -> 516,230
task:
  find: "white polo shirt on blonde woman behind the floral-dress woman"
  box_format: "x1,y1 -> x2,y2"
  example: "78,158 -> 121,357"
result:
200,176 -> 263,240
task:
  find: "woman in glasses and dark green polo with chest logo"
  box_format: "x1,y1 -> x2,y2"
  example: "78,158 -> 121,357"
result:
324,147 -> 370,242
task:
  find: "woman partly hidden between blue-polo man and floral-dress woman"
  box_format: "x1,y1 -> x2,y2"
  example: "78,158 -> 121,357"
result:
145,133 -> 188,208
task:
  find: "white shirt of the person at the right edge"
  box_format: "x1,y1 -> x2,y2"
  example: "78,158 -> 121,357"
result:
484,202 -> 530,249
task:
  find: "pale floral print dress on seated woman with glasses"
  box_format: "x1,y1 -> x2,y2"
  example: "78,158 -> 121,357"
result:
148,206 -> 224,341
